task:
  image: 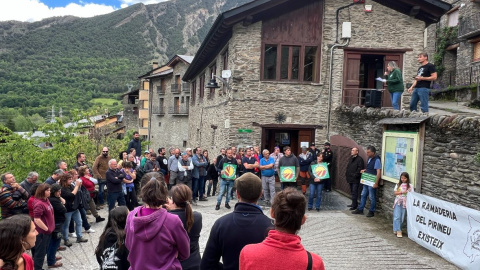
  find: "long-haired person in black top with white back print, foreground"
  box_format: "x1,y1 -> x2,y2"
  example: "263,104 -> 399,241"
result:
95,206 -> 130,270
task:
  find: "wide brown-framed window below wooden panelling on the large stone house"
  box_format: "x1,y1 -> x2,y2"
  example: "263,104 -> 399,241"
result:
263,44 -> 318,82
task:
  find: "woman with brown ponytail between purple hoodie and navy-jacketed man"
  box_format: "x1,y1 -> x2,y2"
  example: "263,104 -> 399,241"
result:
166,184 -> 202,270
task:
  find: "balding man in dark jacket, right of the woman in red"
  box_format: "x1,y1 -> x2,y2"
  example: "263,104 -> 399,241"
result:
106,159 -> 127,212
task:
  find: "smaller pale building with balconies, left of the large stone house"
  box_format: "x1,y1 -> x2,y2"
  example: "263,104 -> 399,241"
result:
138,55 -> 193,151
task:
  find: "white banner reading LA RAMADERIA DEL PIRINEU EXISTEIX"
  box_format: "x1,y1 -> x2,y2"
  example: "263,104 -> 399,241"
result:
407,192 -> 480,270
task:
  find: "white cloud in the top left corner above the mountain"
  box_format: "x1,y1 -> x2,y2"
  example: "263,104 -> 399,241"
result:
0,0 -> 116,22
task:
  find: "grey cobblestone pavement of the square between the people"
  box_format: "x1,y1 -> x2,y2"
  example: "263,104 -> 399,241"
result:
38,191 -> 458,270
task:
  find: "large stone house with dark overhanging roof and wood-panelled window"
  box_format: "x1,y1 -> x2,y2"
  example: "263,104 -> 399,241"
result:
183,0 -> 451,154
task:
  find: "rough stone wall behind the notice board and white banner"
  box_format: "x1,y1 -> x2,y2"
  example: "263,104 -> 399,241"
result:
332,106 -> 480,217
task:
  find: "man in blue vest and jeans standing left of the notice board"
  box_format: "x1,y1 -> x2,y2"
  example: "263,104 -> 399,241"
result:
352,145 -> 382,217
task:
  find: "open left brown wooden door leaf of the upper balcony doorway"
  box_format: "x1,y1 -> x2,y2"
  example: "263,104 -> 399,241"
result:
343,52 -> 362,105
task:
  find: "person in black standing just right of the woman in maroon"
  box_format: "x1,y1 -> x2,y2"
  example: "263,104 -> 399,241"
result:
47,184 -> 67,268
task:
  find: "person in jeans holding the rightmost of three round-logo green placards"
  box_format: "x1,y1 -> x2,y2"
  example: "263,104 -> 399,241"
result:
308,153 -> 330,212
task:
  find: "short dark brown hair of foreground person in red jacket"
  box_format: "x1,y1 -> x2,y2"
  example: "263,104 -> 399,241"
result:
272,187 -> 307,234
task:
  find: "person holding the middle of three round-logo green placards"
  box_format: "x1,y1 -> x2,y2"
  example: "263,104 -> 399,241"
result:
278,146 -> 300,188
